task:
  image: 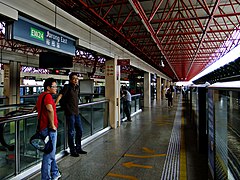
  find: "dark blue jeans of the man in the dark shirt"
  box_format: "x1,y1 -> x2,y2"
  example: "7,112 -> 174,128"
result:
66,114 -> 83,153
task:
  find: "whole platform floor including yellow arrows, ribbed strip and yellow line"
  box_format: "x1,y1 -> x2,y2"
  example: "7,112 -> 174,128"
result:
30,95 -> 208,180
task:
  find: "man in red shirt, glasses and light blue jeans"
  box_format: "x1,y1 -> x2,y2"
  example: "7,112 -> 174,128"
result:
33,78 -> 61,180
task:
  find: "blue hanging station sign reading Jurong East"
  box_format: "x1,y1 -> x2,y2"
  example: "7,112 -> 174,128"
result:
12,16 -> 75,56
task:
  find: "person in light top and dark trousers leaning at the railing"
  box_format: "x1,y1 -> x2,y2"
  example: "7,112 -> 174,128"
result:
122,86 -> 132,122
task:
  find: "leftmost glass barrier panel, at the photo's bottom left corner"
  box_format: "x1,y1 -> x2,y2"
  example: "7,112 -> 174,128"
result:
0,122 -> 15,179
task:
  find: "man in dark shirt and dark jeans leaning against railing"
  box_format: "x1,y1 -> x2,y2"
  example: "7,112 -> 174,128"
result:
56,72 -> 87,157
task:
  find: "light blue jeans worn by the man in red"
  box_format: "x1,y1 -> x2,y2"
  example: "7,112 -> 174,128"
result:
41,128 -> 59,180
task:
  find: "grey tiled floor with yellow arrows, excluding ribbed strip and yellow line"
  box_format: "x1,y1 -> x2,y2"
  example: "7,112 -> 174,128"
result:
31,95 -> 207,180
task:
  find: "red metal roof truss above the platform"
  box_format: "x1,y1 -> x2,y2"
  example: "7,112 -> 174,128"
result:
50,0 -> 240,80
